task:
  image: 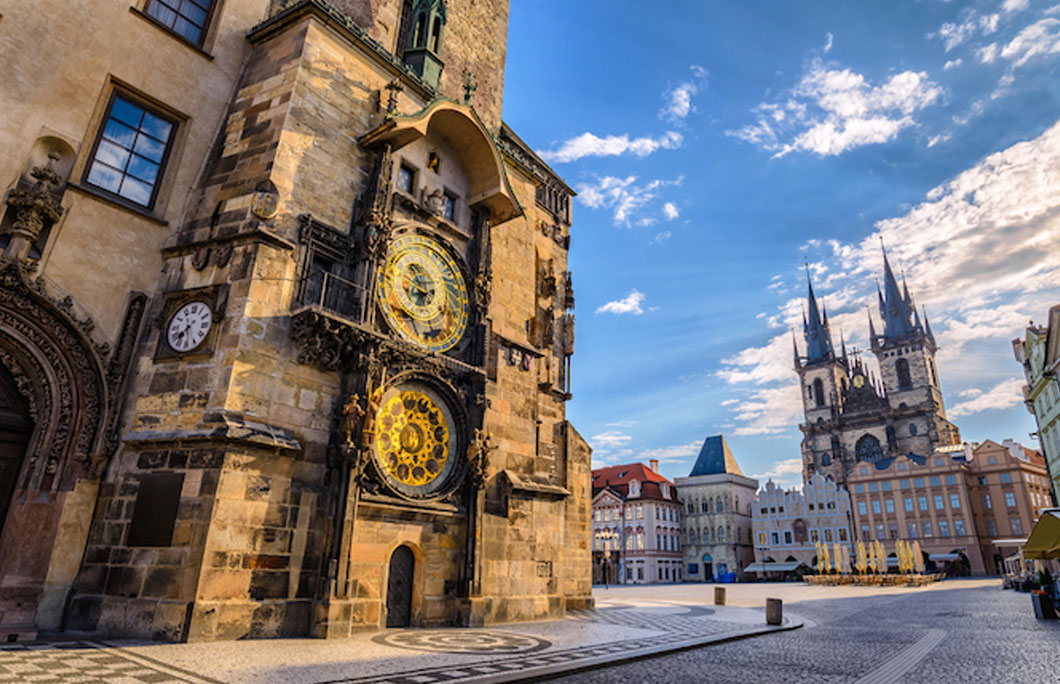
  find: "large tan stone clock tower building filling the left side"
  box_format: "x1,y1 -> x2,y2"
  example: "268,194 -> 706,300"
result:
0,0 -> 591,639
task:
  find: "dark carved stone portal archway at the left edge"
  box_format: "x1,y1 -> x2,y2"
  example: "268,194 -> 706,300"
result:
0,261 -> 146,634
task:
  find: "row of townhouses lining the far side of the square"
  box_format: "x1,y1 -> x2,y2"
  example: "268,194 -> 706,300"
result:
591,435 -> 1052,583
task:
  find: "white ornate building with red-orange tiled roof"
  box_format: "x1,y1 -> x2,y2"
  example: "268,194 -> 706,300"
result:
593,458 -> 682,584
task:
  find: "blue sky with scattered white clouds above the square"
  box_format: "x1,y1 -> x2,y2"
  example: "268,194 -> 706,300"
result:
504,0 -> 1060,487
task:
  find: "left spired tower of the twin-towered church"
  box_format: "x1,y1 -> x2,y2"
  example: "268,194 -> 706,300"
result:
793,271 -> 849,474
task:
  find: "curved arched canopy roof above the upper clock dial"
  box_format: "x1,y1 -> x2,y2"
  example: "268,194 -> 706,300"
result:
358,100 -> 523,224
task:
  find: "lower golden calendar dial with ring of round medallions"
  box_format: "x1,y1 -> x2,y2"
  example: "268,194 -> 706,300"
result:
373,382 -> 458,496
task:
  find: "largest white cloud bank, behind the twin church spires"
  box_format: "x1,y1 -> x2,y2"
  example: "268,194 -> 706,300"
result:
717,116 -> 1060,435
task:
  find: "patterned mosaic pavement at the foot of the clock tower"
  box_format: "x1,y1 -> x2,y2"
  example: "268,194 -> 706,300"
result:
0,587 -> 797,684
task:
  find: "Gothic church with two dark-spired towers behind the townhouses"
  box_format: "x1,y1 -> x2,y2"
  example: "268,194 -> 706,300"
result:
793,252 -> 960,484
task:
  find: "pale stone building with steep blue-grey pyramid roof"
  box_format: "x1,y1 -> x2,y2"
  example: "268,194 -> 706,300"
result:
673,435 -> 758,582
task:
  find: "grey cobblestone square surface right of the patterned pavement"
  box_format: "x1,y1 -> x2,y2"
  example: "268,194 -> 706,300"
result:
553,580 -> 1060,684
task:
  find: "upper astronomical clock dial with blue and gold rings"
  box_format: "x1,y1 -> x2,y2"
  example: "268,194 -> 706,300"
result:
378,235 -> 467,352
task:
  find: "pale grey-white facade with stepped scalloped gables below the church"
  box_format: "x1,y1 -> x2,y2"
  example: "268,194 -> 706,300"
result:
750,473 -> 854,576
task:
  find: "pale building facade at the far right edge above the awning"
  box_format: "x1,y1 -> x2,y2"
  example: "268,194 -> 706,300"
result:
1012,306 -> 1060,505
